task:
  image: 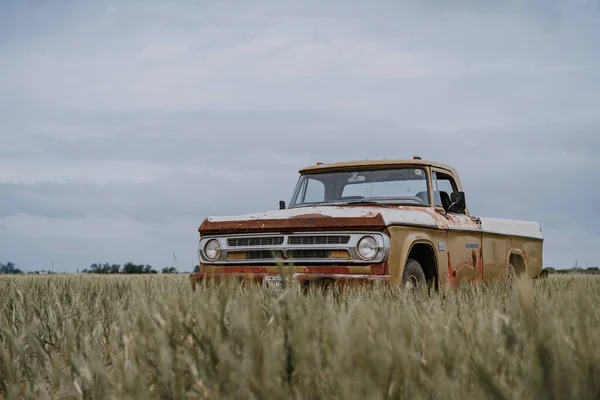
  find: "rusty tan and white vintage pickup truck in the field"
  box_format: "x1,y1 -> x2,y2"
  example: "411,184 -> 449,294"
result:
190,157 -> 545,289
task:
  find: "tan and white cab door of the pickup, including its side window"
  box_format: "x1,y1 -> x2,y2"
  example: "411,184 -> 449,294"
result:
432,168 -> 484,287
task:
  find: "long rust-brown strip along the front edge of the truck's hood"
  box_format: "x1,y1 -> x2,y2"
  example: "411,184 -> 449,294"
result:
198,213 -> 386,236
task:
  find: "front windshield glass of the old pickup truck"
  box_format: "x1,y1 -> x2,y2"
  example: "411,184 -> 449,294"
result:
290,167 -> 429,207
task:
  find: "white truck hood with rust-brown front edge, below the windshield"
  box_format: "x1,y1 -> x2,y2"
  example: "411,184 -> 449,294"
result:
198,206 -> 437,235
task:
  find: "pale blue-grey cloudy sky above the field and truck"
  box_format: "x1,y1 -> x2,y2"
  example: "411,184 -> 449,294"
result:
0,0 -> 600,271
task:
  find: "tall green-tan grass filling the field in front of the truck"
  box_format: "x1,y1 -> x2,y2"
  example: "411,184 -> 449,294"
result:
0,276 -> 600,399
